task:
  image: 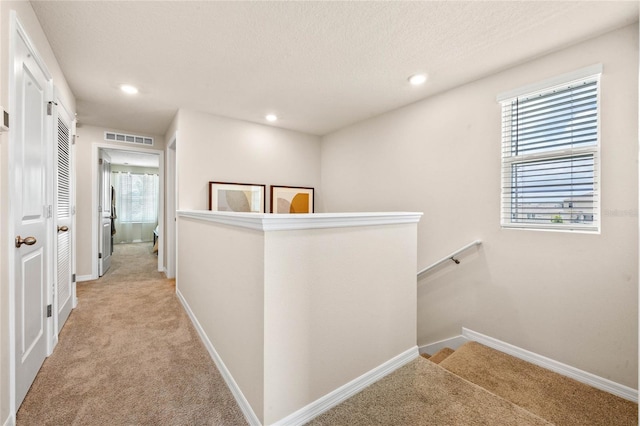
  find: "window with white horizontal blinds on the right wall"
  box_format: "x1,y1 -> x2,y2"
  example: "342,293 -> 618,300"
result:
498,65 -> 602,232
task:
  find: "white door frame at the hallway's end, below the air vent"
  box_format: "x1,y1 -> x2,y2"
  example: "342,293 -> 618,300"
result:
91,142 -> 164,280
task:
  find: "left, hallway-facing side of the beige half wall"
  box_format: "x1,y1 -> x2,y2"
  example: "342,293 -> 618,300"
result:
177,217 -> 265,422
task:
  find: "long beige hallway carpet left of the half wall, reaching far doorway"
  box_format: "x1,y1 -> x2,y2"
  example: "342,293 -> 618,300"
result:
17,243 -> 245,426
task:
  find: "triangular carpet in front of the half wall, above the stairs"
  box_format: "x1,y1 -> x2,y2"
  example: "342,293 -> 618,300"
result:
308,357 -> 550,426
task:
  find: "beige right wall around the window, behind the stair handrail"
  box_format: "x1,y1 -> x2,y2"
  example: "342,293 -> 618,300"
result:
322,25 -> 638,388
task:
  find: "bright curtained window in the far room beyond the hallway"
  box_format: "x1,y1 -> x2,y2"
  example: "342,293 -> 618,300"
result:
113,172 -> 159,224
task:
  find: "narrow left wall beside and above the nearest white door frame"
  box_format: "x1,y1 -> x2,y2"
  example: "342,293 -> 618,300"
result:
0,0 -> 76,424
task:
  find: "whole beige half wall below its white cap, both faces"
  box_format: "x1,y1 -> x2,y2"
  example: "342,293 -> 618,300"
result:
177,213 -> 418,424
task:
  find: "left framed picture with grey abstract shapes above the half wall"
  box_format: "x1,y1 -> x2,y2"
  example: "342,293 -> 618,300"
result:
209,182 -> 266,213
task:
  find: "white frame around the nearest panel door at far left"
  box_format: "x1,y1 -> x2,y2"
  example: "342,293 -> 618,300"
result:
6,10 -> 54,419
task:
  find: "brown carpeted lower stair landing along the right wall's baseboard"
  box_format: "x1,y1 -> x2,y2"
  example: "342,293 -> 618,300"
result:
425,342 -> 638,426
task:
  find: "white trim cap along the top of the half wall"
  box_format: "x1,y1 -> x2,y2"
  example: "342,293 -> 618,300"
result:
177,210 -> 422,231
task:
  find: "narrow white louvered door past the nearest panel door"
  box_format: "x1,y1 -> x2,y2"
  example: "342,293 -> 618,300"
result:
54,100 -> 75,332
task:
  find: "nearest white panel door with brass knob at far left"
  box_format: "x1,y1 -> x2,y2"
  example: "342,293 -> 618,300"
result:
10,25 -> 51,407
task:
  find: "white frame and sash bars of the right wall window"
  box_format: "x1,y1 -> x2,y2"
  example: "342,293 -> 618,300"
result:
497,64 -> 602,234
